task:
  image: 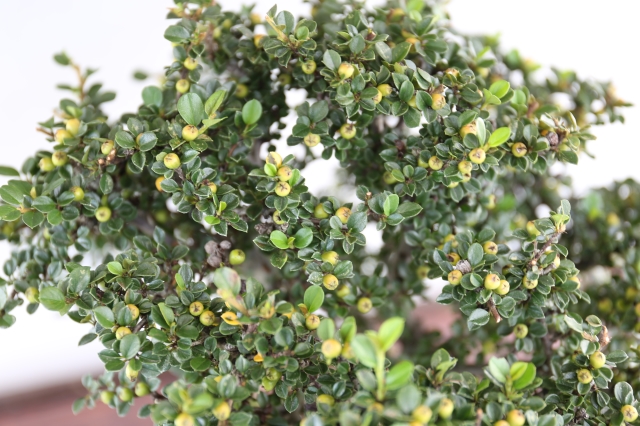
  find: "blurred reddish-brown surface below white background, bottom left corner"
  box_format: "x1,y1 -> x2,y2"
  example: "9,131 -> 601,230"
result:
0,383 -> 153,426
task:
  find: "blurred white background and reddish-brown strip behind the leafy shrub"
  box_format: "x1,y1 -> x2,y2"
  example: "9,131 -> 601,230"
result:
0,0 -> 640,426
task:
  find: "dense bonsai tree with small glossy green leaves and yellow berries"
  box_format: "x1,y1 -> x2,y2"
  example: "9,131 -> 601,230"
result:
0,0 -> 640,426
